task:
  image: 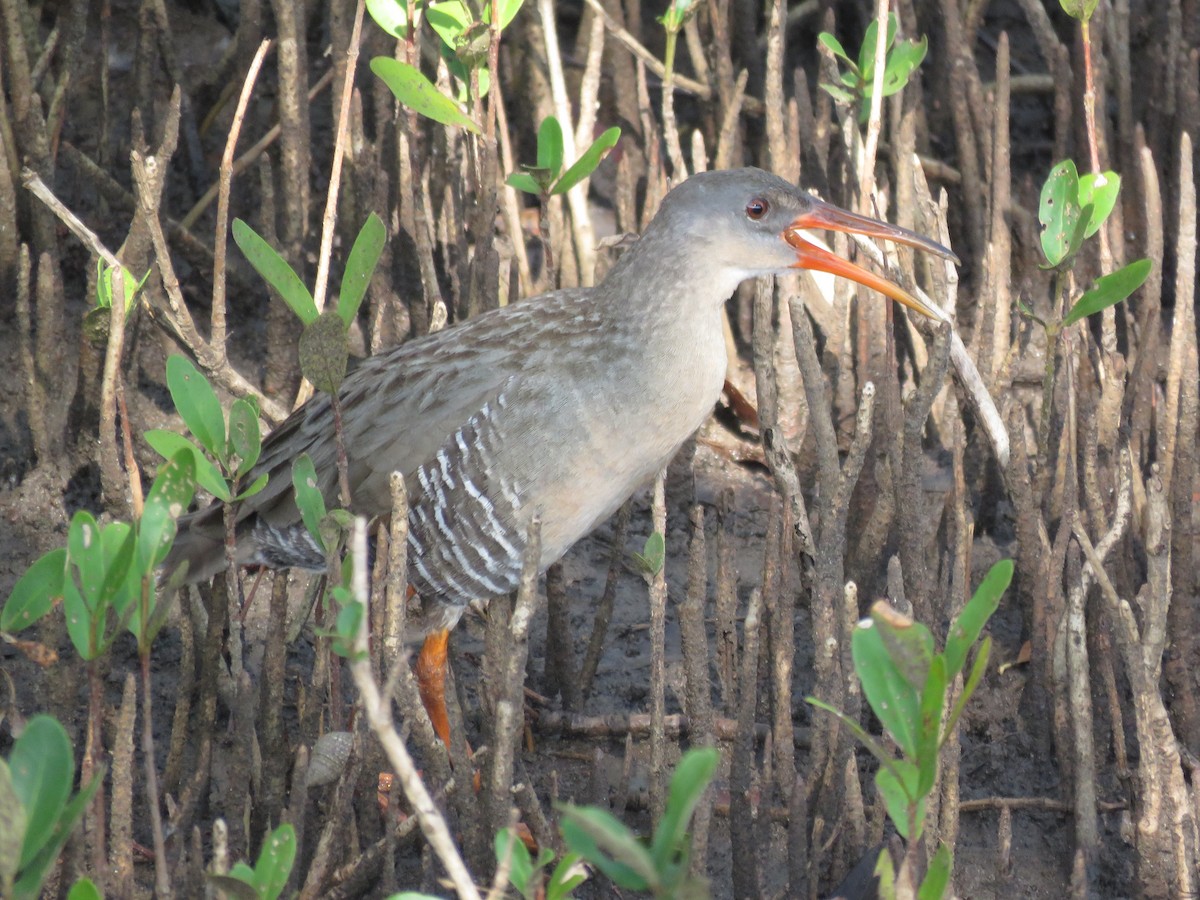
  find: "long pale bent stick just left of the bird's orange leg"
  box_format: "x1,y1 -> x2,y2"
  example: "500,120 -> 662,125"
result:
349,517 -> 480,900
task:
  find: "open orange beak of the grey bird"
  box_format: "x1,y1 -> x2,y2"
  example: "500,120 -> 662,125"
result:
784,197 -> 959,319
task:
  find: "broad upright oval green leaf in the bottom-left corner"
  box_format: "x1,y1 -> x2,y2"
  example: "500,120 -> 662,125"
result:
8,715 -> 74,869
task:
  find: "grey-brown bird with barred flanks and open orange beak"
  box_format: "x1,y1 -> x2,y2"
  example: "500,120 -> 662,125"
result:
166,168 -> 956,740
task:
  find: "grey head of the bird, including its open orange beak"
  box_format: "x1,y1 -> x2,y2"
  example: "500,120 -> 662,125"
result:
644,168 -> 958,318
